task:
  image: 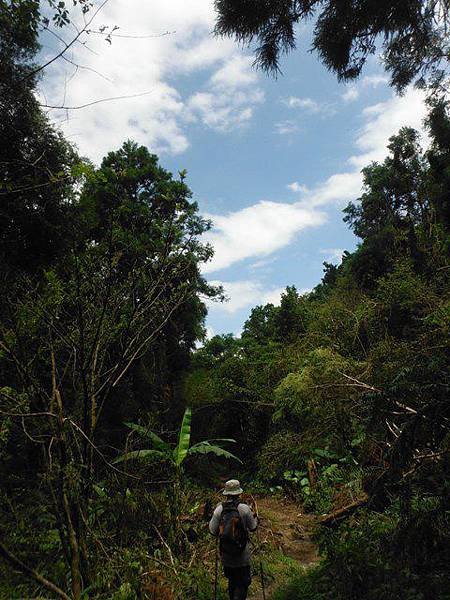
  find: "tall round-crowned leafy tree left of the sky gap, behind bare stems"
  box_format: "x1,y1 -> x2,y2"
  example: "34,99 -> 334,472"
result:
0,143 -> 215,598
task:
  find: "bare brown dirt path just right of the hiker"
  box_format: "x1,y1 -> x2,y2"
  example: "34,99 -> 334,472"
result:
249,496 -> 319,600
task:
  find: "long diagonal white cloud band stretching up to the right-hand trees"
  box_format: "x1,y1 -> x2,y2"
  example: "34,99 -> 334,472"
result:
204,88 -> 426,273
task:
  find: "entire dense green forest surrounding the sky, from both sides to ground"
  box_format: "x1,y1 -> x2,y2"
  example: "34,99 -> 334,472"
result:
0,0 -> 450,600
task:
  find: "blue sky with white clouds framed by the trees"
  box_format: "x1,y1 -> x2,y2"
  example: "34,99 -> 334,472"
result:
40,0 -> 425,334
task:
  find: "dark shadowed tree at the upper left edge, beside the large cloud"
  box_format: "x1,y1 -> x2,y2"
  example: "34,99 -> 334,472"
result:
0,0 -> 79,274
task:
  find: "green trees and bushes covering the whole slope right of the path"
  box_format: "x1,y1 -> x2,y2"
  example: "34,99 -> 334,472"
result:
185,102 -> 450,600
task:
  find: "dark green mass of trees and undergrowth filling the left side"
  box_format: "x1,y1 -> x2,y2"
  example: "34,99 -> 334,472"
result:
0,85 -> 218,599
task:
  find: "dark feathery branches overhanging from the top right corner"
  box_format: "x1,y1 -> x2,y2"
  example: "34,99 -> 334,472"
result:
215,0 -> 449,90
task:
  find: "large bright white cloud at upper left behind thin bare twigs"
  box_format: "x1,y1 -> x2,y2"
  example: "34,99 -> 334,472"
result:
41,0 -> 263,160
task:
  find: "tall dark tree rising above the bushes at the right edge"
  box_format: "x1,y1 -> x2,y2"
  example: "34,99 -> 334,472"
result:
344,123 -> 446,288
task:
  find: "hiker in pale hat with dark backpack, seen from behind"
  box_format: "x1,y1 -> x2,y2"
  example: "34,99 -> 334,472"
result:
209,479 -> 258,600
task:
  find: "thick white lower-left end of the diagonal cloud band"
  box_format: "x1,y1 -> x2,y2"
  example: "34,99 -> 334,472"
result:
204,200 -> 325,273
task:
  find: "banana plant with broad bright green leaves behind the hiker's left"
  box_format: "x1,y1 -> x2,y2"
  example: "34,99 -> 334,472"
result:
115,407 -> 241,470
